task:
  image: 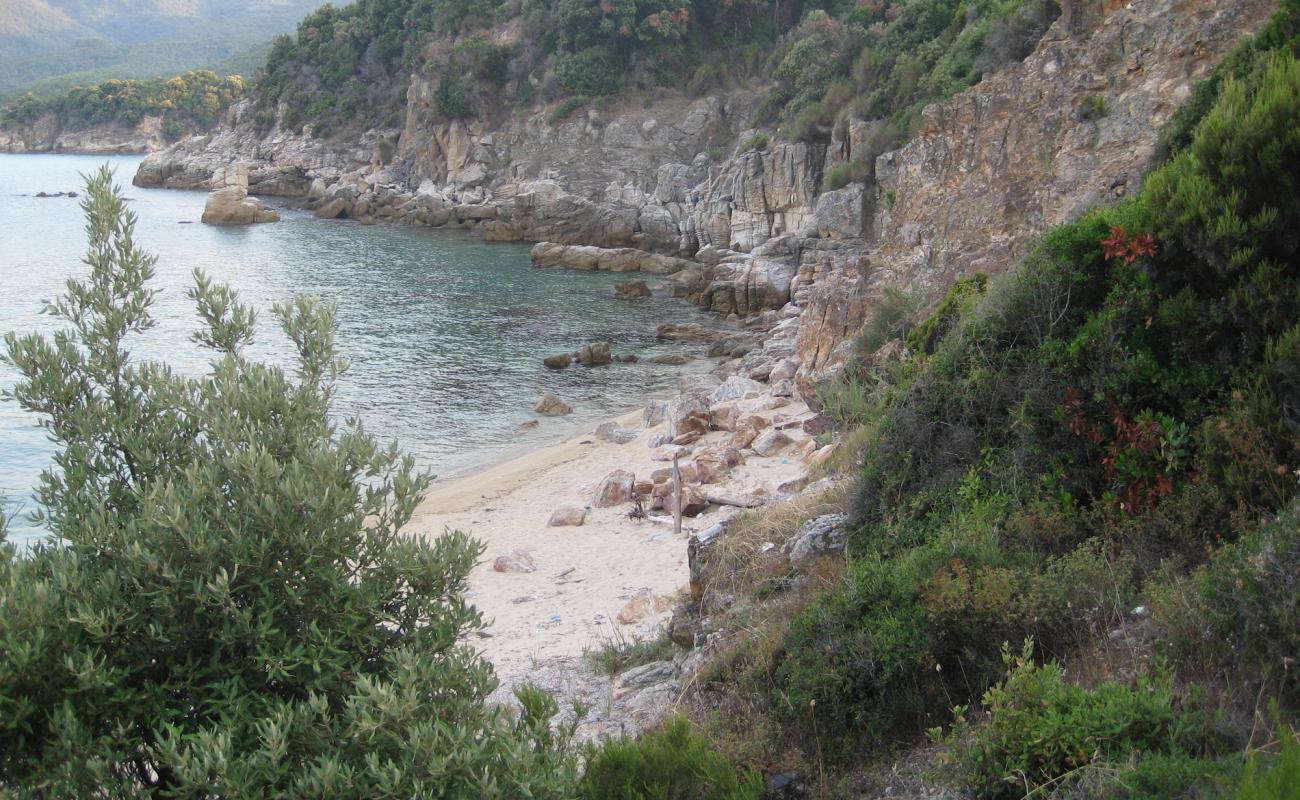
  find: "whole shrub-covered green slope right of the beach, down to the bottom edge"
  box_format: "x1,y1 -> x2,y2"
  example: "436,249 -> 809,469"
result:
681,1 -> 1300,797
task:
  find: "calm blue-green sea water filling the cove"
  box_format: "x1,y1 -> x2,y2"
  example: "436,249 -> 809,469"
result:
0,155 -> 706,540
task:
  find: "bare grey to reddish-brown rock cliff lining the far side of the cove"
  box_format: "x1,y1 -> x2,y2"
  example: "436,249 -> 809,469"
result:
137,0 -> 1277,380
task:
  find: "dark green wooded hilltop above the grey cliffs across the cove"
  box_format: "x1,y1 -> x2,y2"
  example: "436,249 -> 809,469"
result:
250,0 -> 1058,148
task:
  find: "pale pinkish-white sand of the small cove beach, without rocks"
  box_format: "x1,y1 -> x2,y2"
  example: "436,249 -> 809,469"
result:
408,401 -> 807,686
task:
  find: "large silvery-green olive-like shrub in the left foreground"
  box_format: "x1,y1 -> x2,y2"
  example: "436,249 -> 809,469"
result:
0,169 -> 575,797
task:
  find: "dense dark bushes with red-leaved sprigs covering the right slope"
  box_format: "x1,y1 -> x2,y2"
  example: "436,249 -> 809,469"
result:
771,35 -> 1300,769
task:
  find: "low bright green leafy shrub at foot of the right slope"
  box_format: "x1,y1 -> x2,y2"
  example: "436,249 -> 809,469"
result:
949,644 -> 1230,800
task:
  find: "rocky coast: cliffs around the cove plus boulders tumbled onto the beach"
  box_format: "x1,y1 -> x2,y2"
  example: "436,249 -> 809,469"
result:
119,0 -> 1275,738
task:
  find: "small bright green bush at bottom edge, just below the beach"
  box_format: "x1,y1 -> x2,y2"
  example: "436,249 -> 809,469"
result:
580,717 -> 763,800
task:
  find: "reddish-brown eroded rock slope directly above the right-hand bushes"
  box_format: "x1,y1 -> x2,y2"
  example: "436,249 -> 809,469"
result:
794,0 -> 1275,372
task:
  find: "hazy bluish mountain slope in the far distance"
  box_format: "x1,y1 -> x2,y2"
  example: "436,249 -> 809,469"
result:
0,0 -> 324,99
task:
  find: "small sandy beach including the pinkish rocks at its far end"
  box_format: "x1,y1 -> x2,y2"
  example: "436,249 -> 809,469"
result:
406,359 -> 816,738
